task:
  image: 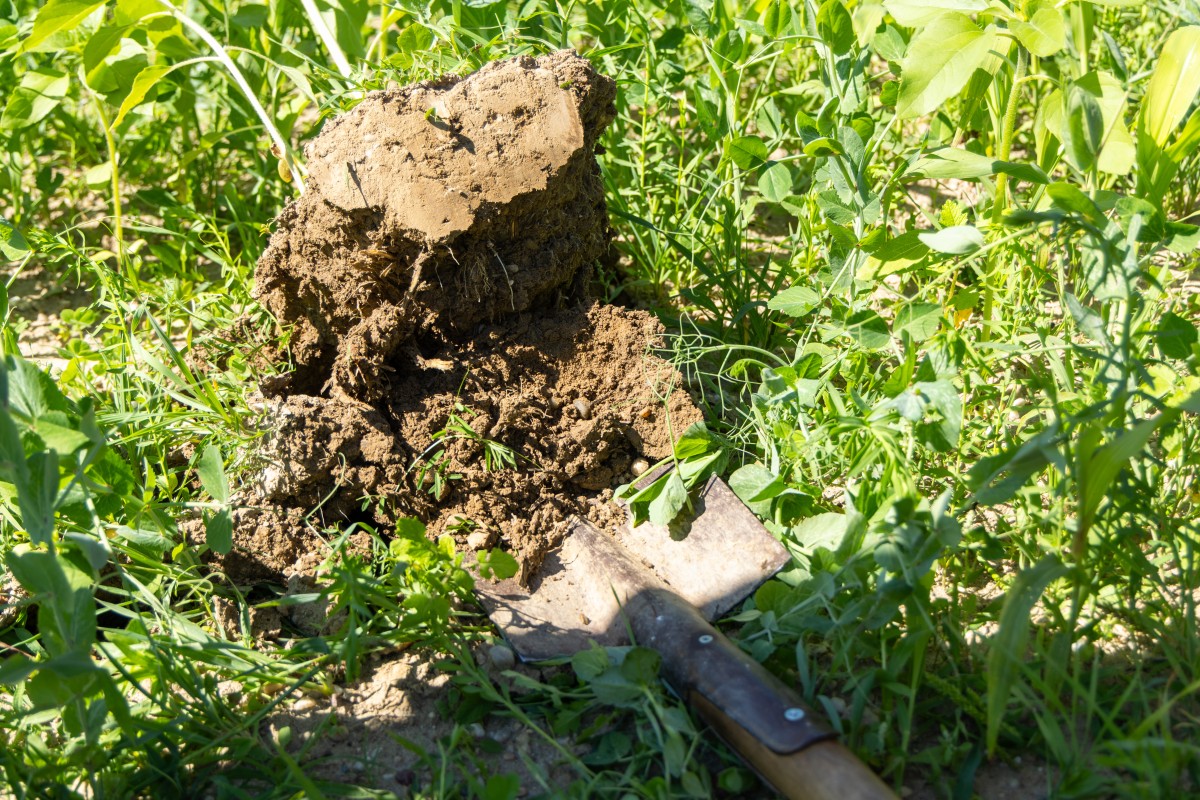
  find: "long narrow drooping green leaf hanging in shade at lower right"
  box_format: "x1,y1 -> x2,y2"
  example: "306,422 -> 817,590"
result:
988,555 -> 1067,752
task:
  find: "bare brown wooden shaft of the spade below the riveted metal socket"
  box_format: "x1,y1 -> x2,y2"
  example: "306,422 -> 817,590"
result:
689,694 -> 896,800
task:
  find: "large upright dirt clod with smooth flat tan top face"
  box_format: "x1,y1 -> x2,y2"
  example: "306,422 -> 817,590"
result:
257,50 -> 616,401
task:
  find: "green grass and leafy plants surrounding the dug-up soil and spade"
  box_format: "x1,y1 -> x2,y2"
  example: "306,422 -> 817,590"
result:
0,0 -> 1200,798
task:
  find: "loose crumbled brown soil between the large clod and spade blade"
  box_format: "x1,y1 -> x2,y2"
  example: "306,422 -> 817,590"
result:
238,299 -> 700,577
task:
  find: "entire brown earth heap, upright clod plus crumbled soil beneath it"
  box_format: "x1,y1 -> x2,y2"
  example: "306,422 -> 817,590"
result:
223,52 -> 701,581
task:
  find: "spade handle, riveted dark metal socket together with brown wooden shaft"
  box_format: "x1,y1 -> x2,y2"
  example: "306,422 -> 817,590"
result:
624,589 -> 895,800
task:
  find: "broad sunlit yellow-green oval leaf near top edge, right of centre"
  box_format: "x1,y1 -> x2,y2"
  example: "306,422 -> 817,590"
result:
896,12 -> 1008,119
